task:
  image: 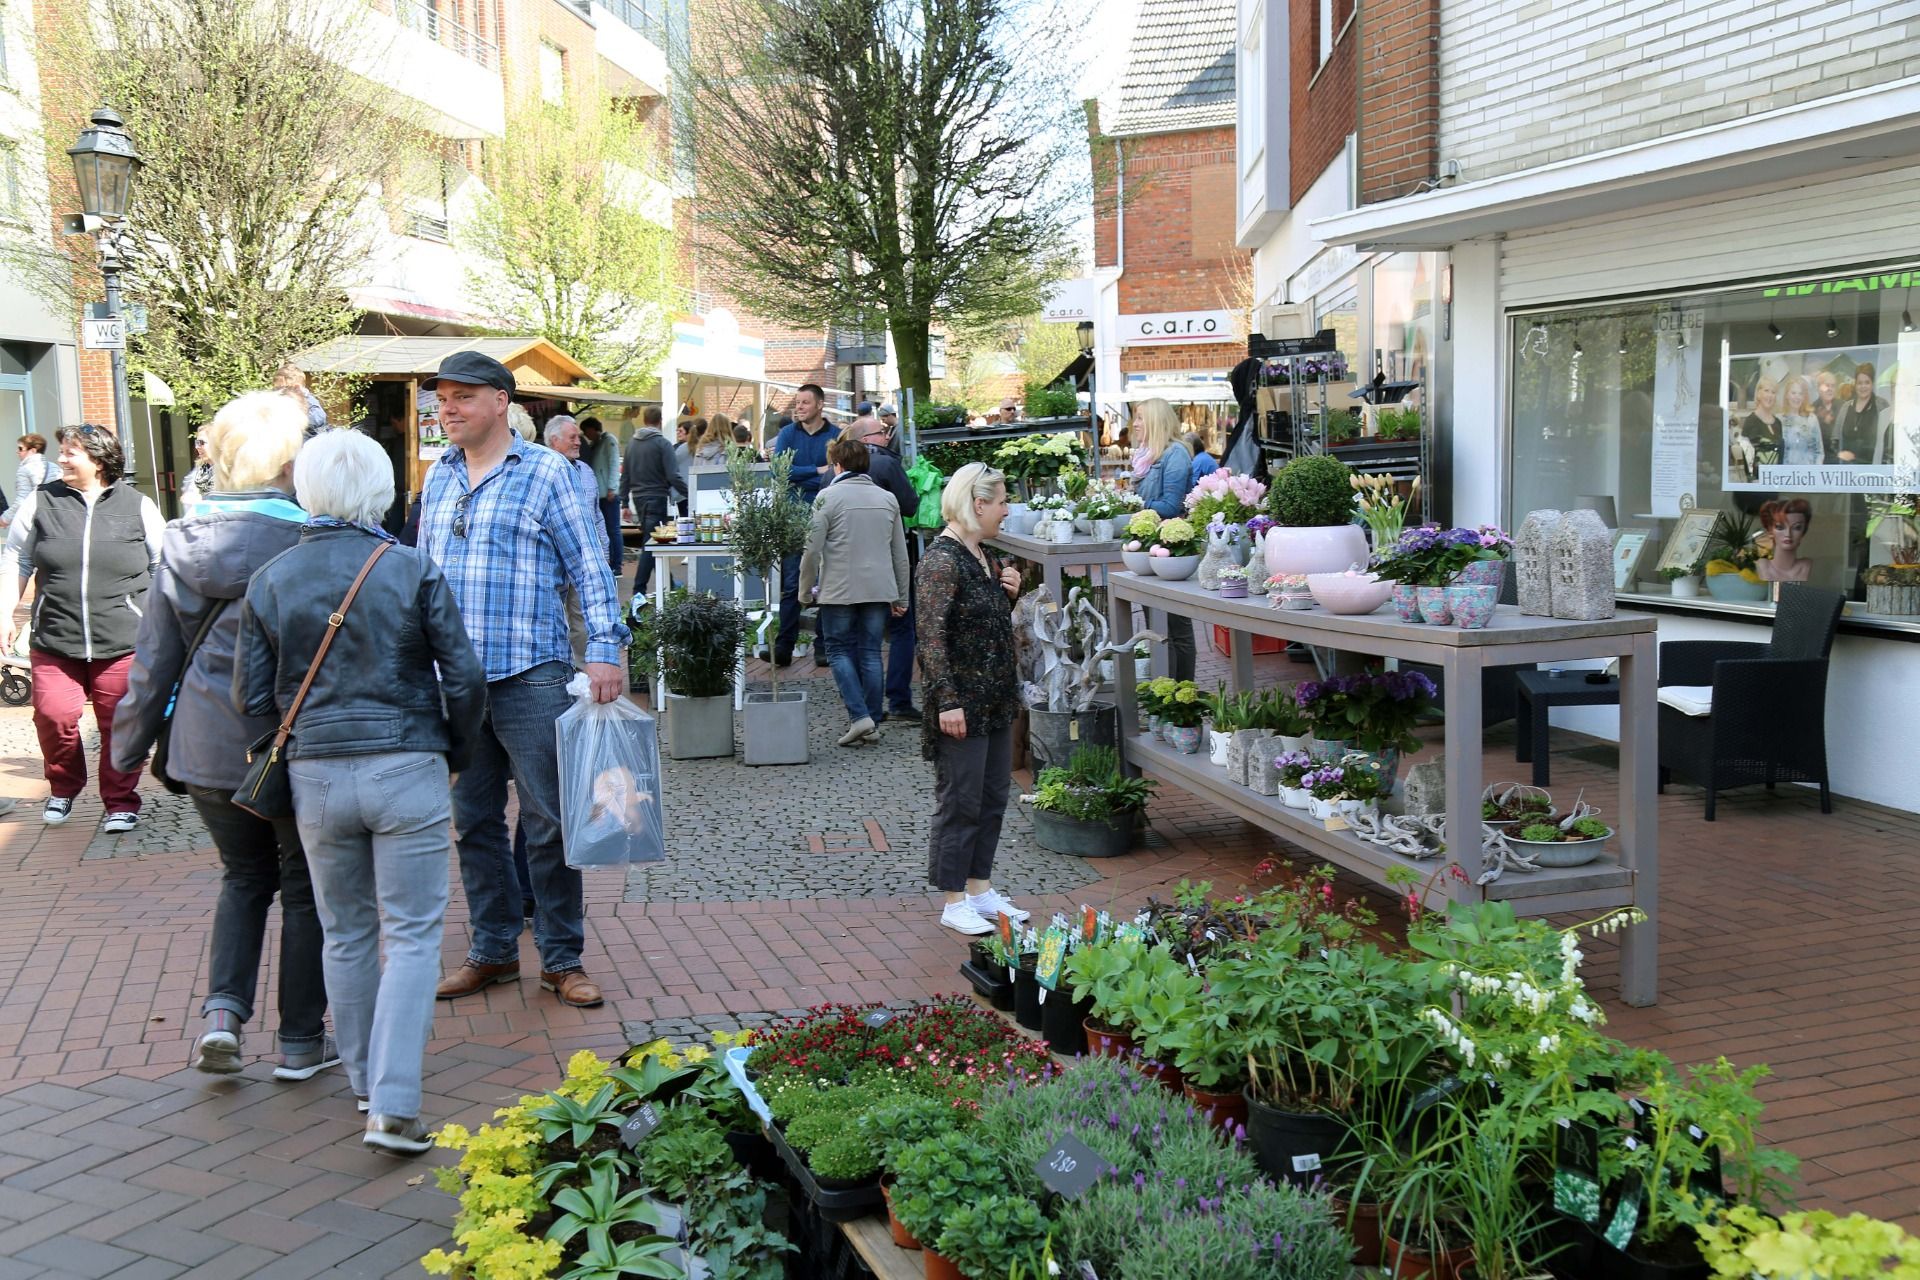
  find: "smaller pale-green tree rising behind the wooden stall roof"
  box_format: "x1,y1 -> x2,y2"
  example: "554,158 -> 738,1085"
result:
455,100 -> 680,391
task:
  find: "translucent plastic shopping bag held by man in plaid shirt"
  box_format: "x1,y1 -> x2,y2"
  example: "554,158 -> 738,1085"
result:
555,674 -> 666,867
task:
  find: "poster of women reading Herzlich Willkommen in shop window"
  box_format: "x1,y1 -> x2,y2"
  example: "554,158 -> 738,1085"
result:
1720,344 -> 1920,493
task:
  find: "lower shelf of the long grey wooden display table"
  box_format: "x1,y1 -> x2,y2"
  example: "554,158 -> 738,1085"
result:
1123,733 -> 1634,915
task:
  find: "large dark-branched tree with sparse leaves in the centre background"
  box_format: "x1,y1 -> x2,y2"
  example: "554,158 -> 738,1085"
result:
680,0 -> 1087,397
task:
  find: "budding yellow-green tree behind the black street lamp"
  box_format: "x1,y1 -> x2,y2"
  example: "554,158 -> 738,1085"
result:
12,0 -> 415,415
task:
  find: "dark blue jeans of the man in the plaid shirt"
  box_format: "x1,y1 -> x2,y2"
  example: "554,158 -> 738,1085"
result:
453,662 -> 586,973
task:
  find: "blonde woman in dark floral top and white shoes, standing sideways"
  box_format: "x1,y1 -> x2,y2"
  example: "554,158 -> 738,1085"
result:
914,462 -> 1027,935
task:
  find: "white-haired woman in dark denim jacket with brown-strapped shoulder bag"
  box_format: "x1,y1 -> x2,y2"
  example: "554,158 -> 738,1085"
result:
232,432 -> 486,1155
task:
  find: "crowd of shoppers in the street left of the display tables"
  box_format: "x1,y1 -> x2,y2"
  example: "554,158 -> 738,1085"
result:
0,351 -> 1105,1153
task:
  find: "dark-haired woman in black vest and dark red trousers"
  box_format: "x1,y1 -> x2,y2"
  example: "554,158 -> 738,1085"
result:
0,424 -> 165,833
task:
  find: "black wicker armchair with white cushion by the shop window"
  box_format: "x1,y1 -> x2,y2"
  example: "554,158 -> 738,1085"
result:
1659,583 -> 1845,821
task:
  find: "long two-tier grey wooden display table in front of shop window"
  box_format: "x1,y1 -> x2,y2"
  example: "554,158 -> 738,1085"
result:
1108,572 -> 1659,1006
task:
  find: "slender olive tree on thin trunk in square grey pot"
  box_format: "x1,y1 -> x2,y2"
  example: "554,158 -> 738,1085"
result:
726,449 -> 812,764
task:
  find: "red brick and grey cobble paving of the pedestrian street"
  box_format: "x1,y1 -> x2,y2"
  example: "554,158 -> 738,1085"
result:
0,666 -> 1920,1280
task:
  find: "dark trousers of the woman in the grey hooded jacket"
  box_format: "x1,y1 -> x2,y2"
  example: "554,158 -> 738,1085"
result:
186,787 -> 326,1054
